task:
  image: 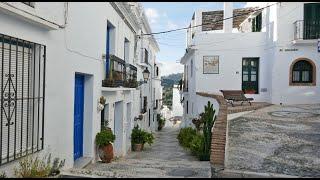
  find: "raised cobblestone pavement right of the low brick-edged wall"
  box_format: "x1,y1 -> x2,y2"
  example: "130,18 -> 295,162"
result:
226,104 -> 320,177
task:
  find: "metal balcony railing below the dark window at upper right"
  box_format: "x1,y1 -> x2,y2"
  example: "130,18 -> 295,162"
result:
293,20 -> 320,40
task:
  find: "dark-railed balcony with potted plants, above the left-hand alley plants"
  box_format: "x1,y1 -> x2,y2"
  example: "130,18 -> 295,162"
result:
102,54 -> 138,88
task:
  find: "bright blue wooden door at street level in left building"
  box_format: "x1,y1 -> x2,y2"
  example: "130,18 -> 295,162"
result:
73,74 -> 84,160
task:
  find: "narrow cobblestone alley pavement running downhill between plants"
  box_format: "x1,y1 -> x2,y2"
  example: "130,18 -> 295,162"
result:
70,124 -> 211,178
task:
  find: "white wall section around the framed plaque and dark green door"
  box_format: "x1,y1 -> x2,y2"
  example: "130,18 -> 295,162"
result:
194,32 -> 271,101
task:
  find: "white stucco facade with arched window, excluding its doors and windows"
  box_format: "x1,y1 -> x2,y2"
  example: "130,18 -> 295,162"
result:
181,2 -> 320,126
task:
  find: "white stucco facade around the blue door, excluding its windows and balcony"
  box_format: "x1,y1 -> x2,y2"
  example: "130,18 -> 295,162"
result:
0,2 -> 162,175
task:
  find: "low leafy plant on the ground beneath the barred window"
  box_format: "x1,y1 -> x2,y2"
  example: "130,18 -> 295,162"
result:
14,154 -> 65,178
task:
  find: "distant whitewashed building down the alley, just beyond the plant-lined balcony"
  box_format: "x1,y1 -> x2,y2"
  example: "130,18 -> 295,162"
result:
130,2 -> 162,132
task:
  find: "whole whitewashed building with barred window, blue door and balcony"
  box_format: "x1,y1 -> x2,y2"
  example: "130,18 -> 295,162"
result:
0,2 -> 159,174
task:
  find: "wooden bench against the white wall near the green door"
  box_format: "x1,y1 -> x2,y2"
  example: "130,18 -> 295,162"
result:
220,90 -> 253,107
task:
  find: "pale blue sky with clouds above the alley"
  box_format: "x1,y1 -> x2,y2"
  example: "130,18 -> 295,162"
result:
142,2 -> 245,75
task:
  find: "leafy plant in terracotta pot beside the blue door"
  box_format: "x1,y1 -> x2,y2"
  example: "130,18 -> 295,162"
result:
96,128 -> 116,163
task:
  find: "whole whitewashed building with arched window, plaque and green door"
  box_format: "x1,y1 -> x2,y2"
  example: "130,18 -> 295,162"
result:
181,2 -> 320,127
